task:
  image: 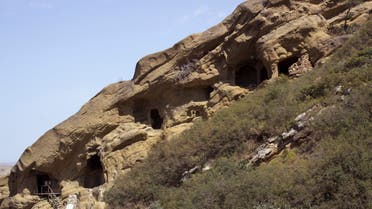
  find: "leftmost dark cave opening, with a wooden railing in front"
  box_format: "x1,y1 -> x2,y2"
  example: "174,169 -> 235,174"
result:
36,173 -> 61,196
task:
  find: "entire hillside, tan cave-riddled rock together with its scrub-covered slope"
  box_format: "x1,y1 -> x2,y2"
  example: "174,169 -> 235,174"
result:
0,0 -> 372,209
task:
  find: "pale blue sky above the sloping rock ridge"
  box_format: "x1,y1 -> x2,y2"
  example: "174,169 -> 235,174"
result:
0,0 -> 243,162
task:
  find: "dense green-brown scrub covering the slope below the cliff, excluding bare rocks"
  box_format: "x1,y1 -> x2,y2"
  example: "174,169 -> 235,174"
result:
105,18 -> 372,209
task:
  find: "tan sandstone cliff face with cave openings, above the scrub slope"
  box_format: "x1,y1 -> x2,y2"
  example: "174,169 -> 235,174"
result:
0,0 -> 372,208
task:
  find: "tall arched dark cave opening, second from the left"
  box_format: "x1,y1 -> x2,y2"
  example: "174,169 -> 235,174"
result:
84,154 -> 105,188
